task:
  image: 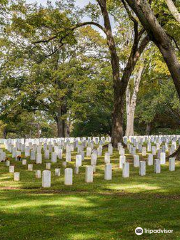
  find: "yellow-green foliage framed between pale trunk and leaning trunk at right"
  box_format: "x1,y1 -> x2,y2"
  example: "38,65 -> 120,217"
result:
136,43 -> 180,134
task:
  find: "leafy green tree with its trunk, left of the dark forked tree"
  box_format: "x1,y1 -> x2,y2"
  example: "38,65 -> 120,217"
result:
1,1 -> 112,137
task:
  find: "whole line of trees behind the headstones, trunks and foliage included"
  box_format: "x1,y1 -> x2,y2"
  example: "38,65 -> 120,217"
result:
0,0 -> 180,144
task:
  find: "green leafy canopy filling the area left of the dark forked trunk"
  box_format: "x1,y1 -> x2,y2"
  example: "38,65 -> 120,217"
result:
0,2 -> 112,139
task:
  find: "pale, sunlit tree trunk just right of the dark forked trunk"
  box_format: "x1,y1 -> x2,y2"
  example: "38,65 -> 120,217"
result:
126,66 -> 144,137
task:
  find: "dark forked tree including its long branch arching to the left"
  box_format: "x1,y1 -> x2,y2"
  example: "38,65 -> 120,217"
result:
12,0 -> 149,147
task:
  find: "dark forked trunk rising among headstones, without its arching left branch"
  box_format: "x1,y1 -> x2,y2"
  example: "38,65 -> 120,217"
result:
97,0 -> 149,147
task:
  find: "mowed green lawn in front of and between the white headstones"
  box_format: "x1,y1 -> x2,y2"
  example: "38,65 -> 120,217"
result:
0,146 -> 180,240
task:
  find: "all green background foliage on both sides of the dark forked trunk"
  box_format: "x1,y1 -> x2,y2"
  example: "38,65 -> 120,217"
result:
0,0 -> 180,136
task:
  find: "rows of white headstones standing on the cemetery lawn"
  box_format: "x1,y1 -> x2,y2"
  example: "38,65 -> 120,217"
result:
0,135 -> 180,188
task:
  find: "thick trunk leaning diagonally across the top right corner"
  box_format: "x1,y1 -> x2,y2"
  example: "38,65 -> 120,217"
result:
126,0 -> 180,158
